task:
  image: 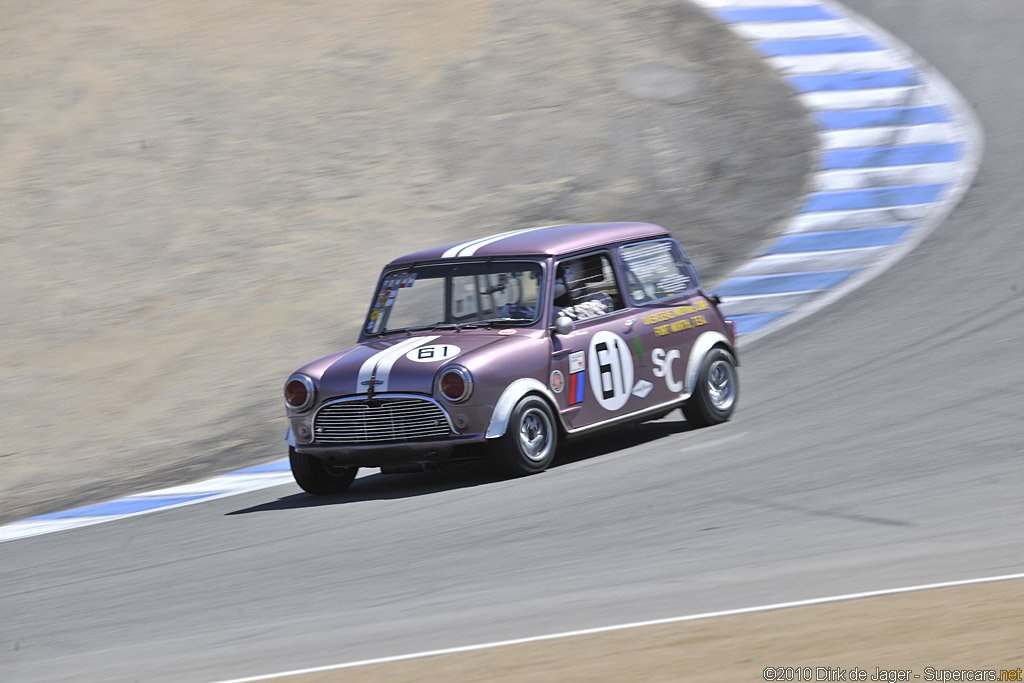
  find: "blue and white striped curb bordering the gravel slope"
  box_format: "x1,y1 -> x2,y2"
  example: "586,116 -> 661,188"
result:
0,0 -> 982,543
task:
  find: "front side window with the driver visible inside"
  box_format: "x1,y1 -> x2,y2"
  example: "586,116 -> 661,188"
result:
552,254 -> 624,321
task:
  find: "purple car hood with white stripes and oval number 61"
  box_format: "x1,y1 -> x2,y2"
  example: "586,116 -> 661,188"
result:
300,330 -> 532,398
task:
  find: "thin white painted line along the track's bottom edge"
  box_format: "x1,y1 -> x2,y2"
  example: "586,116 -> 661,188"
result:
203,573 -> 1024,683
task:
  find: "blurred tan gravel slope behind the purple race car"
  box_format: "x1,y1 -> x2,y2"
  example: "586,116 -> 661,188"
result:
0,0 -> 814,522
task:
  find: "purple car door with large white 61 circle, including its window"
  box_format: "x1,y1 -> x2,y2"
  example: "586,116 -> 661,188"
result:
550,251 -> 637,429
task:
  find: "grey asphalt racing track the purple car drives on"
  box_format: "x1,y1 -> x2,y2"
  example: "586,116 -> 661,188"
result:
0,0 -> 1024,681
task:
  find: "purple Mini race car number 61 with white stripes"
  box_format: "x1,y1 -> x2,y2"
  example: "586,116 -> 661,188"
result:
285,223 -> 738,494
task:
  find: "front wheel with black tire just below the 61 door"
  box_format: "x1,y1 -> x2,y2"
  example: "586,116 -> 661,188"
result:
489,396 -> 558,476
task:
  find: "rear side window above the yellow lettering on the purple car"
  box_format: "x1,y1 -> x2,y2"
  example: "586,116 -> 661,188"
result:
620,240 -> 700,303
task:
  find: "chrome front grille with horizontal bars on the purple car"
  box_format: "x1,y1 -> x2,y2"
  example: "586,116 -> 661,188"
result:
313,396 -> 452,443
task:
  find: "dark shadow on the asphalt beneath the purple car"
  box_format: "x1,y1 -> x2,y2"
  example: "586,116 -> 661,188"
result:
226,418 -> 693,515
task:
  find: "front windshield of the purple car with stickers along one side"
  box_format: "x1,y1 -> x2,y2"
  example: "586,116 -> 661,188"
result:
365,261 -> 543,334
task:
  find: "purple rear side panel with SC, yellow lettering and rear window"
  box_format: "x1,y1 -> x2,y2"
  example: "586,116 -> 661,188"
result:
618,239 -> 711,405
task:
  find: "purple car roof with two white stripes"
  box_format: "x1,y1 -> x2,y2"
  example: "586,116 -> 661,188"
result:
388,223 -> 669,265
